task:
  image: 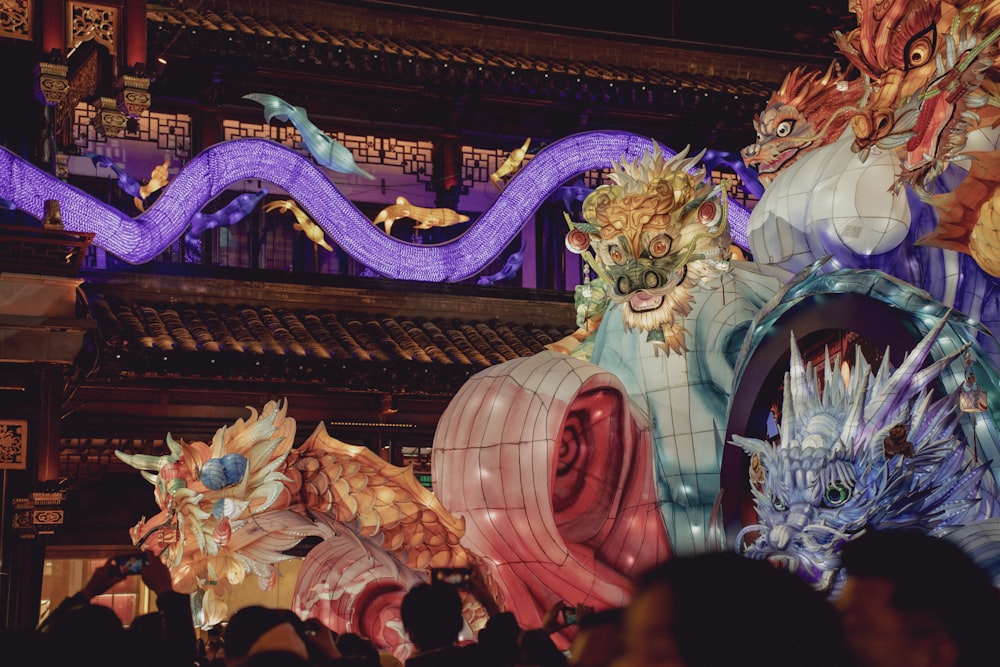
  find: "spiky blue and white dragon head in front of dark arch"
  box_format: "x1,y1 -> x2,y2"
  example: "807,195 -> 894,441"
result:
733,319 -> 998,592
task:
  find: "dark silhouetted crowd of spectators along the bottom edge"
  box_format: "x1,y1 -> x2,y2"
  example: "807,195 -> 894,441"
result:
0,530 -> 1000,667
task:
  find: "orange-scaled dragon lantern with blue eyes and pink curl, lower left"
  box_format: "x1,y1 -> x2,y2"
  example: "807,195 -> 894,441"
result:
116,401 -> 488,656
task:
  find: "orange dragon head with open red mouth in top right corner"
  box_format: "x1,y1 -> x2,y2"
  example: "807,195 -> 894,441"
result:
834,0 -> 1000,189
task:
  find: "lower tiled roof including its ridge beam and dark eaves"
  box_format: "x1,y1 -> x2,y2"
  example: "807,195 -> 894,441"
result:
85,278 -> 575,393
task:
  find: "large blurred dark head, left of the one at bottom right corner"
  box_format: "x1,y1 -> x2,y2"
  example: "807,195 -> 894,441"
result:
619,553 -> 852,667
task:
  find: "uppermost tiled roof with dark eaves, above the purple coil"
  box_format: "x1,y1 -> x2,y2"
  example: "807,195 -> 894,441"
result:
147,0 -> 833,145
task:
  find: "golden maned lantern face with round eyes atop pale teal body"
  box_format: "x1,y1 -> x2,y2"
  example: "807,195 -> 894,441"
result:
570,146 -> 730,353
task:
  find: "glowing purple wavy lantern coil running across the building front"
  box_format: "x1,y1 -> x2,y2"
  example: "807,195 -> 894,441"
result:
0,132 -> 749,282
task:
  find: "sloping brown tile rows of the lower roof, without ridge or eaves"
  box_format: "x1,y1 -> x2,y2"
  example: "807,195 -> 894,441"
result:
90,295 -> 573,380
